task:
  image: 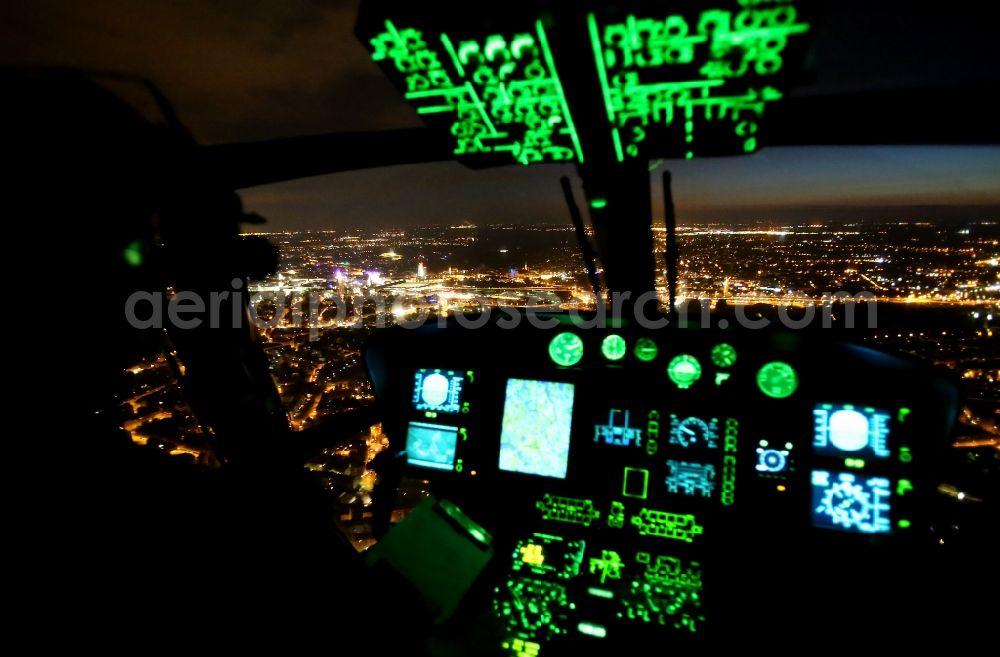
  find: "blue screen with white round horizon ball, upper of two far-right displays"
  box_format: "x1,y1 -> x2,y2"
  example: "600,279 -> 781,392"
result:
813,404 -> 890,459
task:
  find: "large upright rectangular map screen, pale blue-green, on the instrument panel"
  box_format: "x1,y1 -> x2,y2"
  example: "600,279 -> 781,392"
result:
500,379 -> 574,479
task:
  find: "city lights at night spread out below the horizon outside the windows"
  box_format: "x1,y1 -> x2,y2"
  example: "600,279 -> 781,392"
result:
115,220 -> 1000,550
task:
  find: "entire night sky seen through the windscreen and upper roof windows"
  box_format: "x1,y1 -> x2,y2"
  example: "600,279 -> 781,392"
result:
0,0 -> 1000,229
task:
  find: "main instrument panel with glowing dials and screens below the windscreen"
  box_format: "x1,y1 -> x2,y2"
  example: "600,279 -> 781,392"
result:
365,317 -> 958,655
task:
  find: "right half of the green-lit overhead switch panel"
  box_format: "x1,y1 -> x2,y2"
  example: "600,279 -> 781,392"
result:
587,2 -> 810,161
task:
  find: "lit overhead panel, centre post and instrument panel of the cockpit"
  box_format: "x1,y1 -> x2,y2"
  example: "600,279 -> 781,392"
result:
348,2 -> 980,655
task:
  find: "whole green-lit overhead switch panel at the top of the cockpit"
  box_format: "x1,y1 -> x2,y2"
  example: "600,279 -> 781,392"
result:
358,0 -> 814,165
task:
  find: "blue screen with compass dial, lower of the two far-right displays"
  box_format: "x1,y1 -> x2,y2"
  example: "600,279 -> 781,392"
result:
812,470 -> 891,534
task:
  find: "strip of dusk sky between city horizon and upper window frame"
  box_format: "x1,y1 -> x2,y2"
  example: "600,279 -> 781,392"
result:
232,146 -> 1000,230
